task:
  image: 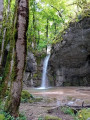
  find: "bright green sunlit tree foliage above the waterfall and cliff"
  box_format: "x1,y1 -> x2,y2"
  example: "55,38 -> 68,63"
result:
27,0 -> 90,51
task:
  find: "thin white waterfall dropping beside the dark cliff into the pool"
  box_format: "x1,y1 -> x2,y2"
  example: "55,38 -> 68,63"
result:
41,54 -> 50,89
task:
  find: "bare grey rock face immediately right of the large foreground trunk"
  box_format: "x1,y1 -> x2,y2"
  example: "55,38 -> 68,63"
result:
23,52 -> 37,86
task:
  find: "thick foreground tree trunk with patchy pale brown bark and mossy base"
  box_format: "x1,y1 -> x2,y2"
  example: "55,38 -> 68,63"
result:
5,0 -> 28,117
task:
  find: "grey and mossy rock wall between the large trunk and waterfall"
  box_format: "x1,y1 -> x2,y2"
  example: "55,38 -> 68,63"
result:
23,51 -> 46,87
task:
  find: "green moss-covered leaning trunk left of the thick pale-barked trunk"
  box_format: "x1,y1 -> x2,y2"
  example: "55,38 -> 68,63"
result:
0,0 -> 17,98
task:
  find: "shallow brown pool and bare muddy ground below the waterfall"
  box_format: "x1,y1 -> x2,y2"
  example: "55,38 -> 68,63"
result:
20,87 -> 90,120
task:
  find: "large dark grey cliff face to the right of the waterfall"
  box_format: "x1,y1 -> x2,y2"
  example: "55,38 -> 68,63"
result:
49,17 -> 90,86
